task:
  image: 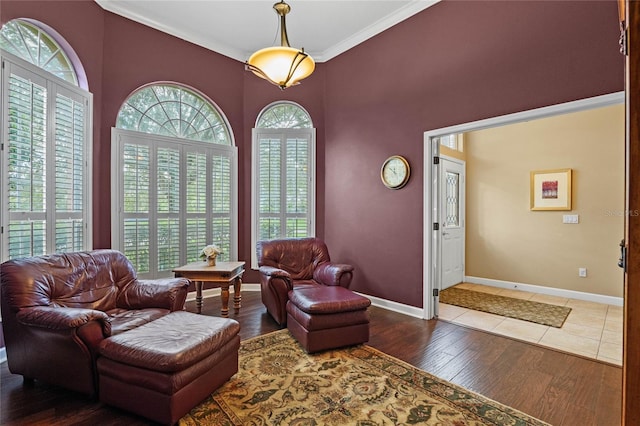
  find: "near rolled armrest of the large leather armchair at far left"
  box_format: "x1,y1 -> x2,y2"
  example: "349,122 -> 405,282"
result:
16,306 -> 111,336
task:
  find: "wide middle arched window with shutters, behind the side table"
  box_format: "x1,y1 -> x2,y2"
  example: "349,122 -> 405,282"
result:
111,83 -> 237,277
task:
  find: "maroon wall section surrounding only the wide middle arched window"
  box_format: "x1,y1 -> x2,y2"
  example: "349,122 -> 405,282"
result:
99,12 -> 248,248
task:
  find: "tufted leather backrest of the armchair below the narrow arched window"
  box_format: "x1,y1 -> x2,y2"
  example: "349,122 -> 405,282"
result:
257,238 -> 330,280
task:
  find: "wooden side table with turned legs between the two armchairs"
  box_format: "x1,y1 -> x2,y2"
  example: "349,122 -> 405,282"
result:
173,261 -> 244,317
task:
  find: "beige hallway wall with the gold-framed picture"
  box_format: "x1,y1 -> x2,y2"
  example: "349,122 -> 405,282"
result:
464,105 -> 624,297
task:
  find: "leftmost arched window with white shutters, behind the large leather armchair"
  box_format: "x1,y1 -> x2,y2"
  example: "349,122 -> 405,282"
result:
0,19 -> 93,259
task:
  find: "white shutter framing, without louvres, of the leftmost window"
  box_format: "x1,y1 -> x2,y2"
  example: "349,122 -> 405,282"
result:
0,49 -> 93,261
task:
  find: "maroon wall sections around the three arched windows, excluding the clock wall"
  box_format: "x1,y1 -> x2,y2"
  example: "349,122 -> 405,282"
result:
0,0 -> 324,282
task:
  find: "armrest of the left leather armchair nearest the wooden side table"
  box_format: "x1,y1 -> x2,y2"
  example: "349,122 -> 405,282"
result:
116,278 -> 189,311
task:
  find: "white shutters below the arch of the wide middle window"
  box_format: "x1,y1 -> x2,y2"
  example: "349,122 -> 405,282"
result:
112,129 -> 237,278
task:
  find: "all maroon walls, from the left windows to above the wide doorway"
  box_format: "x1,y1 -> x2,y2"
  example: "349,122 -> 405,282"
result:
0,0 -> 623,306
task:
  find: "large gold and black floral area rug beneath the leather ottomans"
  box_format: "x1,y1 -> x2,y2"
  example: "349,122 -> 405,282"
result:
180,329 -> 547,426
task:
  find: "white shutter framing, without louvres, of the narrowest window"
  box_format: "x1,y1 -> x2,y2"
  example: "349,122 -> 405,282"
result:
251,118 -> 316,269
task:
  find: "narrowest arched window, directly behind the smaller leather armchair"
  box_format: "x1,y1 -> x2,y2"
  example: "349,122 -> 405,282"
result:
252,101 -> 316,266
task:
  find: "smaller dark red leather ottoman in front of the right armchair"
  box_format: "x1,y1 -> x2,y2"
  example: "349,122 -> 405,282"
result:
287,285 -> 371,353
